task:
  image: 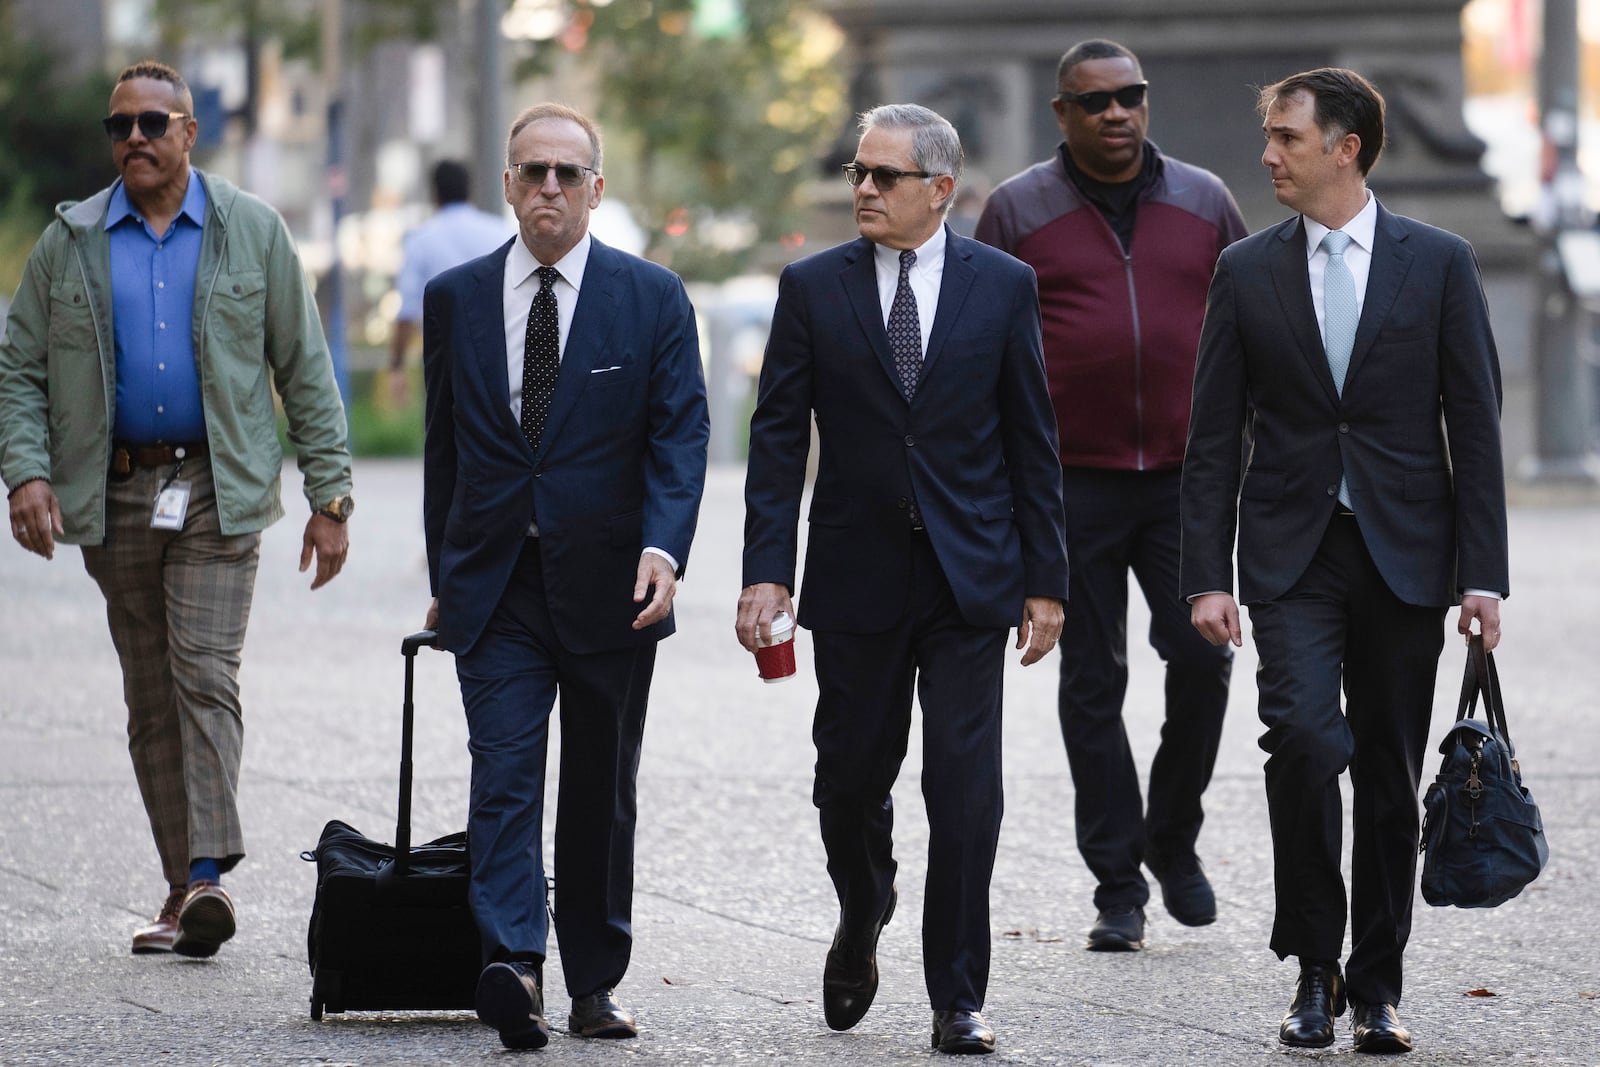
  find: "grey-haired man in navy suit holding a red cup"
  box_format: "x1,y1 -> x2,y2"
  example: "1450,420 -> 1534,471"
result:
736,104 -> 1067,1053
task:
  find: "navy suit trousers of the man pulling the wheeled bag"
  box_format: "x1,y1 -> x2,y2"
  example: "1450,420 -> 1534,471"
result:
456,537 -> 656,997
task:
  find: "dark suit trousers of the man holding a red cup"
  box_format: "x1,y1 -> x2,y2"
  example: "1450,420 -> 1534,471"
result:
811,533 -> 1006,1011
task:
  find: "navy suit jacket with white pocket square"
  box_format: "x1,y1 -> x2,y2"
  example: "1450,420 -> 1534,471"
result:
422,238 -> 709,653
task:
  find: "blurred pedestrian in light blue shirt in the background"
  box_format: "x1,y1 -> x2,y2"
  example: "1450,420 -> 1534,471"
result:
389,160 -> 515,408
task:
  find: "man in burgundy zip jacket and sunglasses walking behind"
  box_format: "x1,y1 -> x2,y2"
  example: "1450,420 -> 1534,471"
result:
976,40 -> 1245,950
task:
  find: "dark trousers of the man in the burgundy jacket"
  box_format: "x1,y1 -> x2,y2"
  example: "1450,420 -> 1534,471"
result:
1058,467 -> 1234,909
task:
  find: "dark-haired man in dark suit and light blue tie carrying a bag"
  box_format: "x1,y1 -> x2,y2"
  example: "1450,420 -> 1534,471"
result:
1181,69 -> 1510,1053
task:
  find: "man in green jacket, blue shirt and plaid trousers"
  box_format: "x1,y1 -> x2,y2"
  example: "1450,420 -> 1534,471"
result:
0,62 -> 350,957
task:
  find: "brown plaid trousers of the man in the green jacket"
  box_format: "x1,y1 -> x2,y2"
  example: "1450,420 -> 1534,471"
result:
83,458 -> 261,888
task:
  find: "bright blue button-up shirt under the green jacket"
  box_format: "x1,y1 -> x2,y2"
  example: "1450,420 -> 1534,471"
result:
106,171 -> 206,445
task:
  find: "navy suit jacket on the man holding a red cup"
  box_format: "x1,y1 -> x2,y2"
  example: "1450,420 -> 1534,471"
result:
744,227 -> 1067,633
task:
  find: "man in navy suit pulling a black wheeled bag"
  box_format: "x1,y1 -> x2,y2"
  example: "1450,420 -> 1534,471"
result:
422,104 -> 709,1048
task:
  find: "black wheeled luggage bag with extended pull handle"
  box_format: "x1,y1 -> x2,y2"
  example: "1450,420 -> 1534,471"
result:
301,630 -> 483,1019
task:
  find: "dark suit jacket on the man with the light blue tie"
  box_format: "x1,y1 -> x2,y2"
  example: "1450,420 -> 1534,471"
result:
1181,205 -> 1510,606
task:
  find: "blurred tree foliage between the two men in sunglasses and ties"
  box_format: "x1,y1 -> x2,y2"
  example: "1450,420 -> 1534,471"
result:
518,0 -> 846,280
